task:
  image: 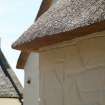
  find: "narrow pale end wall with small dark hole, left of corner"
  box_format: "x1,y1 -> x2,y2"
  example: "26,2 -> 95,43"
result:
24,53 -> 39,105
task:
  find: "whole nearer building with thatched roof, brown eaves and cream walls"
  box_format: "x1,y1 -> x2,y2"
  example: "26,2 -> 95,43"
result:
12,0 -> 105,105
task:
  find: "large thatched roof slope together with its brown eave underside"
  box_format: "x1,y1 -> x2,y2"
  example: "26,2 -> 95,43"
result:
12,0 -> 105,50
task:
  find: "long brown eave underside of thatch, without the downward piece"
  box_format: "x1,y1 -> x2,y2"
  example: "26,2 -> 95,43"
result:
13,21 -> 105,52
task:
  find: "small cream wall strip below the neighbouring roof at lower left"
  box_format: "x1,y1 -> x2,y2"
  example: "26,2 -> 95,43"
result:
0,98 -> 21,105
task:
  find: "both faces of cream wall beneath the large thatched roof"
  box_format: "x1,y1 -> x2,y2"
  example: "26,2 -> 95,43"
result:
24,32 -> 105,105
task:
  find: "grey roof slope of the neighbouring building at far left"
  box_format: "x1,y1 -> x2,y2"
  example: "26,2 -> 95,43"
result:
0,49 -> 23,98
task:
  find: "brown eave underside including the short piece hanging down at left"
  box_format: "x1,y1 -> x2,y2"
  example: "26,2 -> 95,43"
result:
15,21 -> 105,69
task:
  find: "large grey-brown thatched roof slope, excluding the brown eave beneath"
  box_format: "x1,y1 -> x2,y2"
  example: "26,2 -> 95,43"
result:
13,0 -> 105,48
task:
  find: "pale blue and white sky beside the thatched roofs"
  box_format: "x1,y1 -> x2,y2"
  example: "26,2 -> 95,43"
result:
0,0 -> 42,85
